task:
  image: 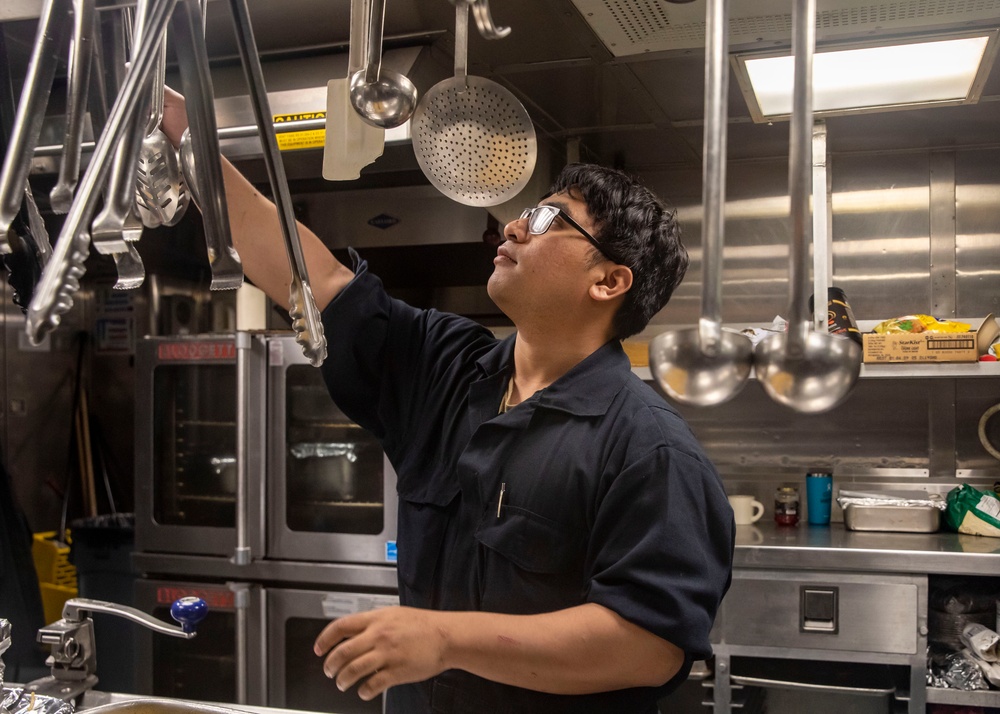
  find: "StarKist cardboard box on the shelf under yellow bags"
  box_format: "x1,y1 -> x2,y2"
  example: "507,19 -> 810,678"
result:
863,314 -> 1000,364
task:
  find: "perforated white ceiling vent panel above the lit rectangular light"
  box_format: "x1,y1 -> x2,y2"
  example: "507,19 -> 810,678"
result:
572,0 -> 1000,57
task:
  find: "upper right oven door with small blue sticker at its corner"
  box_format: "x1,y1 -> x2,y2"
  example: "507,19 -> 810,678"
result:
267,335 -> 396,564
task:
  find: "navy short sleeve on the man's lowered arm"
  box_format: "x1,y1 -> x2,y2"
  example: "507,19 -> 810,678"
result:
587,446 -> 735,659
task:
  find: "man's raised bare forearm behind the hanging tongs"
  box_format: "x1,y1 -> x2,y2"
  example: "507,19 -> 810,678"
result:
222,158 -> 354,310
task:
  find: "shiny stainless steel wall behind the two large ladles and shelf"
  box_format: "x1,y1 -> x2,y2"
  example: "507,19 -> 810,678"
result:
642,148 -> 1000,495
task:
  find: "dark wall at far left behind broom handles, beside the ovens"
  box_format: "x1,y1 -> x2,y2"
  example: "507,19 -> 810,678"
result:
0,280 -> 149,532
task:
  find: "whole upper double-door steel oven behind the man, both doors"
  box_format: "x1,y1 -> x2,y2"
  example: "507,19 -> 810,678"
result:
136,332 -> 396,564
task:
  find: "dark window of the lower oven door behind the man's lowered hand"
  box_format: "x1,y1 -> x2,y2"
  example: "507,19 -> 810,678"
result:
284,617 -> 383,714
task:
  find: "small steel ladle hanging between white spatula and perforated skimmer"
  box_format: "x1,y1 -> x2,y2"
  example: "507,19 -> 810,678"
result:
351,0 -> 417,129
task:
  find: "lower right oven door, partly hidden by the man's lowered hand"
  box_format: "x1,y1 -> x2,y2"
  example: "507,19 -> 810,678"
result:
267,588 -> 399,714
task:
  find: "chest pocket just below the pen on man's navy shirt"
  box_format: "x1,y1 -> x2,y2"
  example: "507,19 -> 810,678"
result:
476,506 -> 586,614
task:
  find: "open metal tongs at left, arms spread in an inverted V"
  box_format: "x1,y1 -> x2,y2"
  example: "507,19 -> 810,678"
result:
27,0 -> 243,344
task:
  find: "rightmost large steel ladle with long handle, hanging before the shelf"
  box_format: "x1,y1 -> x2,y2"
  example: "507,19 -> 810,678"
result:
754,0 -> 861,413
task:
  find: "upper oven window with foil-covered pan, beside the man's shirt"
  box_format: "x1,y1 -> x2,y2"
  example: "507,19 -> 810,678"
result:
285,365 -> 385,535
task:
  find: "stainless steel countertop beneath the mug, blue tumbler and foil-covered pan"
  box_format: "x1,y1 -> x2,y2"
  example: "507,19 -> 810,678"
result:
734,521 -> 1000,575
